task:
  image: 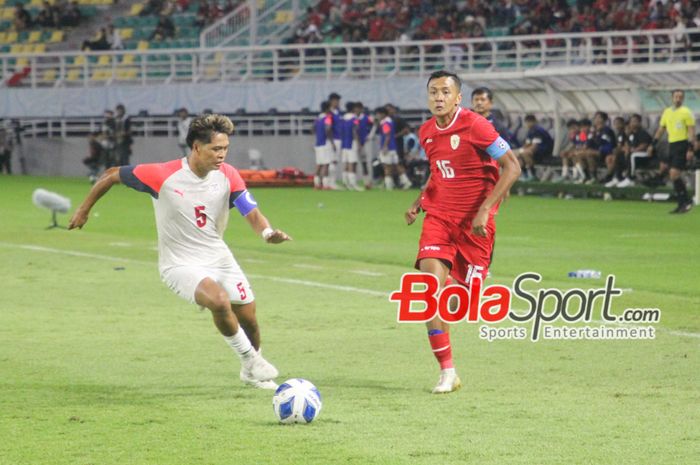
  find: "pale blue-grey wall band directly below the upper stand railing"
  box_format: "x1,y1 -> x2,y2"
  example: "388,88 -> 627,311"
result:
0,77 -> 432,118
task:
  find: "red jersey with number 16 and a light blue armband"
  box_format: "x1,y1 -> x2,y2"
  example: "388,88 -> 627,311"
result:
419,107 -> 510,222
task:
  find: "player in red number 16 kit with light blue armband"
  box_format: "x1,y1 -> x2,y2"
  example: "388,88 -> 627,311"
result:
405,71 -> 520,394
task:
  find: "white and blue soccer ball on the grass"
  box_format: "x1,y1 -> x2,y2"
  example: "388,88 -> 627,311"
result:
272,378 -> 322,423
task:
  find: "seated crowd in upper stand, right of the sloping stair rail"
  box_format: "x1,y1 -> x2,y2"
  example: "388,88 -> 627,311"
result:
292,0 -> 700,43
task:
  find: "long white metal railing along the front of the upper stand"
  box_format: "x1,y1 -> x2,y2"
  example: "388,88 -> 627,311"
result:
0,28 -> 700,87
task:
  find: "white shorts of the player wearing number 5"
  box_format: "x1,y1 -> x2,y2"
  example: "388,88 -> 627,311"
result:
160,264 -> 255,305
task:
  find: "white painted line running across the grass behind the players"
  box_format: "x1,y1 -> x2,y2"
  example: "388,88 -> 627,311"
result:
0,242 -> 700,338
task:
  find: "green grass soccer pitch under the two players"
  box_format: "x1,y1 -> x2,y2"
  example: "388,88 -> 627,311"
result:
0,177 -> 700,465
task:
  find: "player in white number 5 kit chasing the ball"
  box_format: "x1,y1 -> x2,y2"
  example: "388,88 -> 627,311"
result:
68,115 -> 291,389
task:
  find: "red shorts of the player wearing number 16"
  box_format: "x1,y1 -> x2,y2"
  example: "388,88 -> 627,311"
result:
415,214 -> 496,286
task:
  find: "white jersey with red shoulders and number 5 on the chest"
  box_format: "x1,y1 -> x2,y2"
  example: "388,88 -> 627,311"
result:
119,158 -> 254,273
